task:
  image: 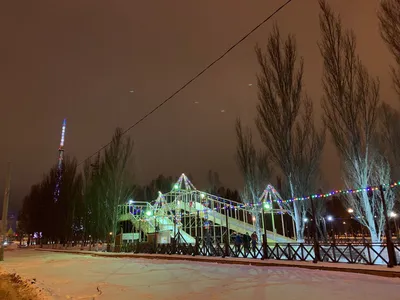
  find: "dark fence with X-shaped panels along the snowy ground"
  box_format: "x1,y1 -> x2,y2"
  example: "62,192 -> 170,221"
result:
114,241 -> 400,266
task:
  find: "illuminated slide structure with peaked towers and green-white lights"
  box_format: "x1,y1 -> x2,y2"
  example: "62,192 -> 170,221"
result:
117,174 -> 295,244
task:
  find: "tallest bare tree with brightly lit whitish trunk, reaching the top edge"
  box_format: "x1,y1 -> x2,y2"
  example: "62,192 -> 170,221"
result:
319,0 -> 393,242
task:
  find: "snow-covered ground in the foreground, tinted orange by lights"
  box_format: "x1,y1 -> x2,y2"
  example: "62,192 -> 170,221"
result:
0,250 -> 400,300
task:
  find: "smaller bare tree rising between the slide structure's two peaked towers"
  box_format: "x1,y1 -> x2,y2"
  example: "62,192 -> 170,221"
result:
235,118 -> 271,240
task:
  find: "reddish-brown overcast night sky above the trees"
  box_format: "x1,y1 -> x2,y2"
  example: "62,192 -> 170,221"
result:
0,0 -> 395,209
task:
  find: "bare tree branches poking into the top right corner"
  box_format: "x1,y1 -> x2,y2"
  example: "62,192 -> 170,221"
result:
378,0 -> 400,100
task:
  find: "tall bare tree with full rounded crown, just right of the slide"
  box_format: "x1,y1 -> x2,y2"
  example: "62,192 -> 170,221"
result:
256,26 -> 325,241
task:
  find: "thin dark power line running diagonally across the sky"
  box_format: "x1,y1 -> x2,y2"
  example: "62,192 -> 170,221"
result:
78,0 -> 293,166
